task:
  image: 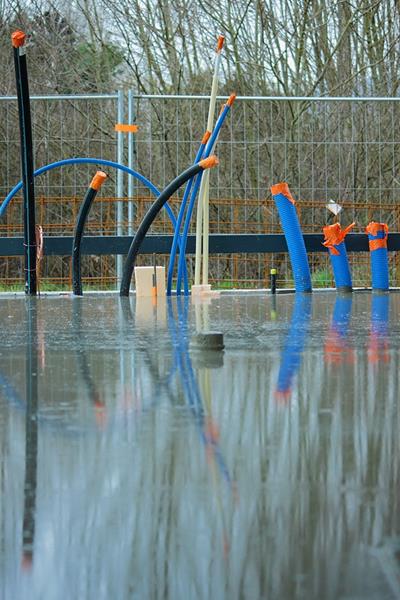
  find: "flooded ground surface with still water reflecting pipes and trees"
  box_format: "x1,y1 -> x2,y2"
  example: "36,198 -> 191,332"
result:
0,293 -> 400,600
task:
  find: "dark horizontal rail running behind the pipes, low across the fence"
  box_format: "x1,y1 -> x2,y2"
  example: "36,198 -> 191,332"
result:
0,233 -> 400,256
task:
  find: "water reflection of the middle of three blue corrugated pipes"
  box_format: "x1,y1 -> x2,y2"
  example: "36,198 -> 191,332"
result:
325,294 -> 354,365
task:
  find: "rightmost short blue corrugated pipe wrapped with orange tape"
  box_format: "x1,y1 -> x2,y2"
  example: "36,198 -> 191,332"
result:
365,221 -> 389,291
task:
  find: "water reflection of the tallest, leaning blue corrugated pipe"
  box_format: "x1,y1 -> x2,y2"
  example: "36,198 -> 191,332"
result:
275,294 -> 312,401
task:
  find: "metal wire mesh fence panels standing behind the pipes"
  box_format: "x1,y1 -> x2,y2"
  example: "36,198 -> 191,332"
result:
0,92 -> 400,287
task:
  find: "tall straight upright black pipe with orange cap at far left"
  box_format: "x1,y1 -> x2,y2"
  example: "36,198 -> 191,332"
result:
11,31 -> 37,296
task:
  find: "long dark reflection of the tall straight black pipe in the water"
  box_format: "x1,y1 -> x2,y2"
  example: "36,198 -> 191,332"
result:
22,298 -> 39,569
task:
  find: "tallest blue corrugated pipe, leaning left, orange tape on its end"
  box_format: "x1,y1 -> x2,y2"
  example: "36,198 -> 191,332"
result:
271,183 -> 312,292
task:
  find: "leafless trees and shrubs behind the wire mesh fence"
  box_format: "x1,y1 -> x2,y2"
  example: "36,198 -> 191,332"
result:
0,0 -> 400,288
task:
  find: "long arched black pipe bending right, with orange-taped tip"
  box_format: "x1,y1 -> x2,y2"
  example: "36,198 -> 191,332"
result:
119,156 -> 218,296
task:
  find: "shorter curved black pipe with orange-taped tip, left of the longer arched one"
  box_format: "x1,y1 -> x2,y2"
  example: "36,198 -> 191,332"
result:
72,171 -> 107,296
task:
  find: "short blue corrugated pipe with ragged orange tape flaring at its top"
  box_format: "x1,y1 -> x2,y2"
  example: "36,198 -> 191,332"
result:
323,223 -> 355,292
